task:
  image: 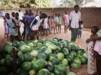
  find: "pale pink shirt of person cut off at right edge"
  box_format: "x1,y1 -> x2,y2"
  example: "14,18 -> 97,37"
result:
94,30 -> 101,55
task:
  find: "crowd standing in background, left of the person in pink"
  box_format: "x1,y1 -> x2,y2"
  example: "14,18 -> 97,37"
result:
4,9 -> 68,41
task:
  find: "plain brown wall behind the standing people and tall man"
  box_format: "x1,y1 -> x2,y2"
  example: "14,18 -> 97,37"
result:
38,8 -> 101,27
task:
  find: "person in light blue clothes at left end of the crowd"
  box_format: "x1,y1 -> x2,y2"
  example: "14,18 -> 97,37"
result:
5,13 -> 17,41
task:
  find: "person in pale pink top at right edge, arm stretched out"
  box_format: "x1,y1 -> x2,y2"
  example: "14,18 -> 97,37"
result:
87,26 -> 101,75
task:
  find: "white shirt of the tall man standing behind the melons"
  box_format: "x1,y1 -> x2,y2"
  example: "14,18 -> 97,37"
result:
69,11 -> 81,28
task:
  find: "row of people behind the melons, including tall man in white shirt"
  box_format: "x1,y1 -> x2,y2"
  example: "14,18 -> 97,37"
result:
1,6 -> 83,42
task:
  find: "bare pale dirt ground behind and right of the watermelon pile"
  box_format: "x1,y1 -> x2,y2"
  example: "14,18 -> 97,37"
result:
41,26 -> 90,75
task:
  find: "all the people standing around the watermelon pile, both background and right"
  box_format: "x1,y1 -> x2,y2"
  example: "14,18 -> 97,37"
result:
0,5 -> 101,75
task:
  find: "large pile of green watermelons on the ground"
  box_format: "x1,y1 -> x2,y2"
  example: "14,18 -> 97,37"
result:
0,38 -> 87,75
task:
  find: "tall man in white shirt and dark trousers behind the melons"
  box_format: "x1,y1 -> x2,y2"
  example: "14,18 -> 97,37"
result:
69,5 -> 81,42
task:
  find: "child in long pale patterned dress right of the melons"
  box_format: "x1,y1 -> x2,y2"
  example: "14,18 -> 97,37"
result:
87,26 -> 98,75
